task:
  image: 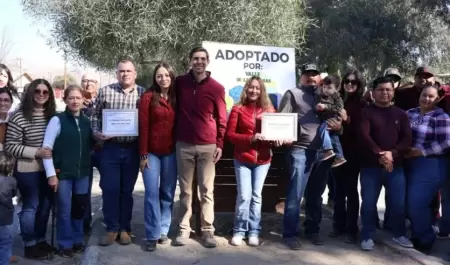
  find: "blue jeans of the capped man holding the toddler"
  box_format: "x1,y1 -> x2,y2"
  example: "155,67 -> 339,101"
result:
283,147 -> 317,238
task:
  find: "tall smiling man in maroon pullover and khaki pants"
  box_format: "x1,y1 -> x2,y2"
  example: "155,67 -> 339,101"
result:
174,47 -> 227,248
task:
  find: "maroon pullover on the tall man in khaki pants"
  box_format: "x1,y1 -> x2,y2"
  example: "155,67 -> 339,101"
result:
175,72 -> 227,148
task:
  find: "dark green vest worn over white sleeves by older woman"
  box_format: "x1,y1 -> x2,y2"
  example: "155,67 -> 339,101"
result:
53,110 -> 95,179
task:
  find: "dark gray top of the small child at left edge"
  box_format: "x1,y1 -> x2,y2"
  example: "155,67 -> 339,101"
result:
0,176 -> 17,226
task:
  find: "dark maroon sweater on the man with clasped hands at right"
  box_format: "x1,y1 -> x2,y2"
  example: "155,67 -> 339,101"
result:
359,104 -> 412,167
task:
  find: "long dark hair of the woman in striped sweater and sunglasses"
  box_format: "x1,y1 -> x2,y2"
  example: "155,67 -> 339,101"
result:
20,78 -> 56,121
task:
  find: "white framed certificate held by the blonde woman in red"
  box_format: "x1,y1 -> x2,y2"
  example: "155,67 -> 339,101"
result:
261,113 -> 298,141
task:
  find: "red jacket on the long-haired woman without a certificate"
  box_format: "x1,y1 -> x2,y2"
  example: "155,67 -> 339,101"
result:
139,92 -> 175,155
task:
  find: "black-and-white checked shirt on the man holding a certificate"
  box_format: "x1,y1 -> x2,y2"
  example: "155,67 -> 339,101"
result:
91,83 -> 144,143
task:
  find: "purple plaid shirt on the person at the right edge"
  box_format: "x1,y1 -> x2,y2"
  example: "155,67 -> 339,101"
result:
407,108 -> 450,156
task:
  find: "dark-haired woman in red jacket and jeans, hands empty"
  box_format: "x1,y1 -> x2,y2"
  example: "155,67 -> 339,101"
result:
139,63 -> 177,251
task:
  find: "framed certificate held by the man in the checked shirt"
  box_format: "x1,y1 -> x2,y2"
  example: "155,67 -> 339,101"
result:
102,109 -> 139,136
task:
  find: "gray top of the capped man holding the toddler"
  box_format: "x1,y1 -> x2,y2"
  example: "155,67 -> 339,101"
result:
278,86 -> 322,150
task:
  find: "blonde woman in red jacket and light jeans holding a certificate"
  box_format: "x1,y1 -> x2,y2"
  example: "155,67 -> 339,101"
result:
227,76 -> 275,246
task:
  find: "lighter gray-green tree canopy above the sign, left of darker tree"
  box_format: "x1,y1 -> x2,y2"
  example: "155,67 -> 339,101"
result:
22,0 -> 311,71
